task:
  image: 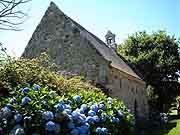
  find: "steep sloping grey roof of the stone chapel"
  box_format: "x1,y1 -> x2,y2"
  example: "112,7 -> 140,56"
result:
36,2 -> 142,80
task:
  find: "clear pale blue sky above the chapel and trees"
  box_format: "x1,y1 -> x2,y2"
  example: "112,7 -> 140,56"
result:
0,0 -> 180,57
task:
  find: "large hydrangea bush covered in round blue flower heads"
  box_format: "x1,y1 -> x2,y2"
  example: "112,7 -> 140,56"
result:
0,85 -> 134,135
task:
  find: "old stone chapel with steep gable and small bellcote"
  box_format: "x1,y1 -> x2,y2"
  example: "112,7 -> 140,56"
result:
22,2 -> 148,117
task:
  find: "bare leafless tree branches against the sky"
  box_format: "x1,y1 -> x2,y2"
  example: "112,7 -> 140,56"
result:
0,0 -> 30,31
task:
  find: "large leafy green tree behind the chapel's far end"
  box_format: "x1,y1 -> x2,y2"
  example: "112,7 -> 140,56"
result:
118,31 -> 180,111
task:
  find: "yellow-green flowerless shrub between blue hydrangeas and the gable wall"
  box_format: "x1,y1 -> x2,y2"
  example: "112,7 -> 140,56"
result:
0,54 -> 94,95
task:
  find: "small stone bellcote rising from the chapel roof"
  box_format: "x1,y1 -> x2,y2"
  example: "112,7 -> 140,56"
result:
105,30 -> 117,50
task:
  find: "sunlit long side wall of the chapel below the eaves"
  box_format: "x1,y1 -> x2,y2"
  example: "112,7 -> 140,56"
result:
106,67 -> 148,117
